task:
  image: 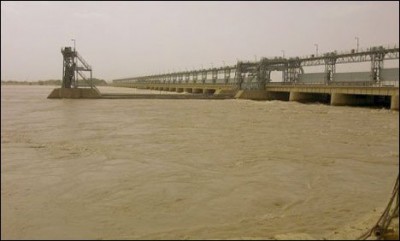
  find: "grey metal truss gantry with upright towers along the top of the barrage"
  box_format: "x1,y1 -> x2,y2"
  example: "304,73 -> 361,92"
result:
114,47 -> 399,89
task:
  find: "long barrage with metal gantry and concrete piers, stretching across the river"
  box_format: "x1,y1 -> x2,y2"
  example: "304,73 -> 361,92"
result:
112,46 -> 399,110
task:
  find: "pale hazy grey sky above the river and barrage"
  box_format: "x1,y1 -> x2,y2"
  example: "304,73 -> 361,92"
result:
1,1 -> 399,81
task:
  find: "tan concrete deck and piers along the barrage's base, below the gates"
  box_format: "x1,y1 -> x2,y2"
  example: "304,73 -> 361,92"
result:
111,83 -> 399,110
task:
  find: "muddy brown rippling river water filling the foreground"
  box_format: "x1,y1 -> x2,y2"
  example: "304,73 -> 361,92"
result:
1,86 -> 399,239
